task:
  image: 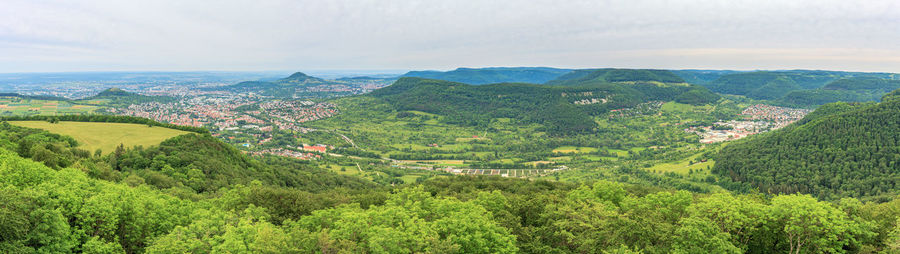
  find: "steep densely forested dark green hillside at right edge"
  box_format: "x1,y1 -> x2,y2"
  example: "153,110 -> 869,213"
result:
712,92 -> 900,199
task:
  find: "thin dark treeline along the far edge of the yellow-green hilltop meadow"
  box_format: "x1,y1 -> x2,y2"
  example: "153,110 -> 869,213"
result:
0,115 -> 209,133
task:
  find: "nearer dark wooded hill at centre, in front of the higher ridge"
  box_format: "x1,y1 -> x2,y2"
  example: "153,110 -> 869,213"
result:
368,78 -> 595,132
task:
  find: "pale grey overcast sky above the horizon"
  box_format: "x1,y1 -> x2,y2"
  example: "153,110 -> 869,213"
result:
0,0 -> 900,73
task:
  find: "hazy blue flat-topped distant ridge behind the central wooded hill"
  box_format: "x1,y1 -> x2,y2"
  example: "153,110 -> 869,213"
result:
401,67 -> 571,85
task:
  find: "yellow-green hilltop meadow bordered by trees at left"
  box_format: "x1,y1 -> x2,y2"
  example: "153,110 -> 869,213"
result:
9,121 -> 189,154
